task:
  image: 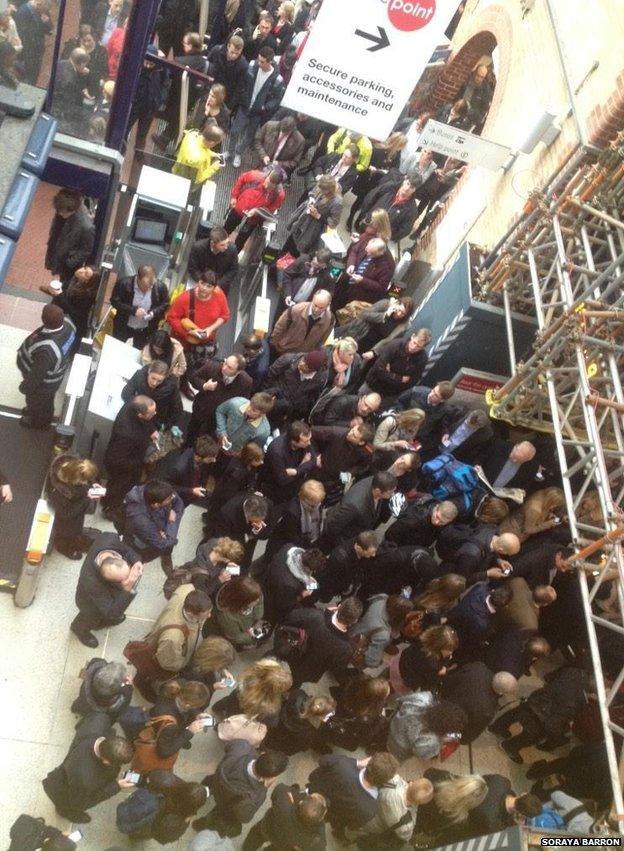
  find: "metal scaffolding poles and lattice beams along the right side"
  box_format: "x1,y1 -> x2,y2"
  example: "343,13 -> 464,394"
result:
475,133 -> 624,831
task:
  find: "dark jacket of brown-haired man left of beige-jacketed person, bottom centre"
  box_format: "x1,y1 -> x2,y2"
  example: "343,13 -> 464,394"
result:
309,754 -> 377,830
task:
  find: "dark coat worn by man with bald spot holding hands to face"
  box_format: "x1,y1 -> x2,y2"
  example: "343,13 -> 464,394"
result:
76,532 -> 139,622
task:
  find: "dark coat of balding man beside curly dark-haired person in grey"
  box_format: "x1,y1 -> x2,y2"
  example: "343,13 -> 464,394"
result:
441,662 -> 498,744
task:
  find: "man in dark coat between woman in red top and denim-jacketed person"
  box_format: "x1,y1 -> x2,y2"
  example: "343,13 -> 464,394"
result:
186,354 -> 252,446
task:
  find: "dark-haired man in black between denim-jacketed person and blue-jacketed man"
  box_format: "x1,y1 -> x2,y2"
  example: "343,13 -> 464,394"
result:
153,434 -> 220,505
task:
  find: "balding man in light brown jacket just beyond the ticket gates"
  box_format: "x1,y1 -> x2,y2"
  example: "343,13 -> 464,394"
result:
270,290 -> 335,360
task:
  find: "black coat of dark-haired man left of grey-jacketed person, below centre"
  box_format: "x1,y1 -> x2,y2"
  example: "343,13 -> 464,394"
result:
285,607 -> 352,685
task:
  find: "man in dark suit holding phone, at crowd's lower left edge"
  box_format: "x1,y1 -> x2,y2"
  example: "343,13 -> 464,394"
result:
43,712 -> 134,824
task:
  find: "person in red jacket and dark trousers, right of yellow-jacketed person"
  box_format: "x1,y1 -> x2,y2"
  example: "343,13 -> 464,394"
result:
223,170 -> 286,251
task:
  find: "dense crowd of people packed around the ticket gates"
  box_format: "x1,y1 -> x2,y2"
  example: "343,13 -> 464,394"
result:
0,0 -> 621,851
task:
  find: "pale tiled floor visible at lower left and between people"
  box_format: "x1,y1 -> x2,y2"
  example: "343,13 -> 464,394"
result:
0,490 -> 540,851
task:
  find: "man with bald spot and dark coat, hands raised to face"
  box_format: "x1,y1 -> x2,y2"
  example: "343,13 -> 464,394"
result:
70,532 -> 143,647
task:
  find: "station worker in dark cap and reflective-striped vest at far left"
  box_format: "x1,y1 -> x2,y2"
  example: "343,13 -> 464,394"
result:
17,304 -> 76,429
